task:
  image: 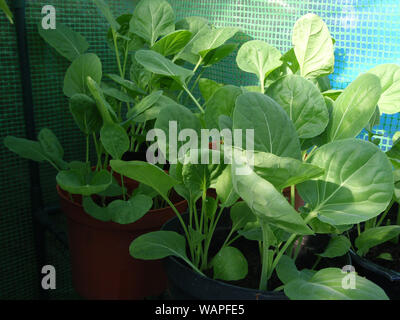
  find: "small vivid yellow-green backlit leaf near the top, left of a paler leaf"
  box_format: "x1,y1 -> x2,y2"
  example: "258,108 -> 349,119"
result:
151,30 -> 192,57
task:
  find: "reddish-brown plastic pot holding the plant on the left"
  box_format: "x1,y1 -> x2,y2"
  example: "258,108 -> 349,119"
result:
57,178 -> 187,300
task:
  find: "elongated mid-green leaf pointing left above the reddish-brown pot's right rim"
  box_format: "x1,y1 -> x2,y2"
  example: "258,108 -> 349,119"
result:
110,160 -> 178,198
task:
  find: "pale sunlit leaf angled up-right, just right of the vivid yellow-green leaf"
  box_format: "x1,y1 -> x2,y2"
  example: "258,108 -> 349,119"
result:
192,27 -> 239,59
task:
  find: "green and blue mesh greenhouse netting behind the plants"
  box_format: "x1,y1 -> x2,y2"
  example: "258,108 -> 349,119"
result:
0,0 -> 400,299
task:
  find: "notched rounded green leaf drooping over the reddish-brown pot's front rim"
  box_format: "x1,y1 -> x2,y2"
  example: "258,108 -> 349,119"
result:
108,195 -> 153,224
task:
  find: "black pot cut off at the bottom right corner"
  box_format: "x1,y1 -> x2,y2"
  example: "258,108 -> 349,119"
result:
350,251 -> 400,300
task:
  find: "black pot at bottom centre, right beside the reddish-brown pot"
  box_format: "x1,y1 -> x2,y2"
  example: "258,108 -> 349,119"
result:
162,217 -> 288,300
